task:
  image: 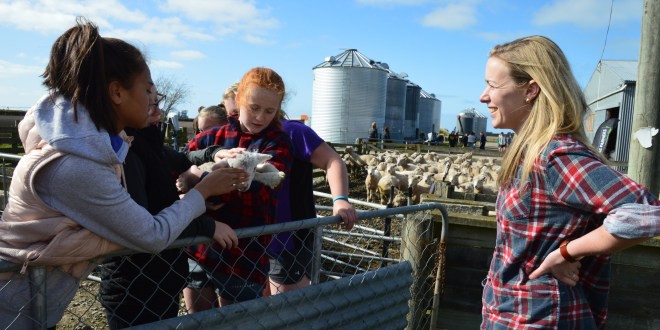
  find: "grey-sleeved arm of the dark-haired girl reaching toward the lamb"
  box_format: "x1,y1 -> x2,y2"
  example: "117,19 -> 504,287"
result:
35,156 -> 245,253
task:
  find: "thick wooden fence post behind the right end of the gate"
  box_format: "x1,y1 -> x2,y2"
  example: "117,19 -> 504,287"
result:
401,210 -> 438,329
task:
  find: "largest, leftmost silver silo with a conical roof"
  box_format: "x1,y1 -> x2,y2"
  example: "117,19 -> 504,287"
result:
311,49 -> 388,143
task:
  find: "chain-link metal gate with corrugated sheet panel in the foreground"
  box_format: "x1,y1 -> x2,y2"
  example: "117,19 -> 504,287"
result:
0,153 -> 447,329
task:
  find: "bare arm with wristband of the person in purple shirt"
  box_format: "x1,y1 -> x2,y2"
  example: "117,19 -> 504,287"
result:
309,142 -> 357,230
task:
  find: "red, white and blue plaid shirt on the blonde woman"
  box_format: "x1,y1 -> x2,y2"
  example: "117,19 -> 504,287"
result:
481,136 -> 658,329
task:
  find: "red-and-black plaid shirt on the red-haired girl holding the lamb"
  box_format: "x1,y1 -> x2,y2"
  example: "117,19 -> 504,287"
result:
184,117 -> 293,283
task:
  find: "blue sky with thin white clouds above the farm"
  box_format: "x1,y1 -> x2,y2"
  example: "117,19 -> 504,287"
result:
0,0 -> 643,130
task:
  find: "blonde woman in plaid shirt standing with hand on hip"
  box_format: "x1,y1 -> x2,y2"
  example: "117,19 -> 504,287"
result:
480,36 -> 660,329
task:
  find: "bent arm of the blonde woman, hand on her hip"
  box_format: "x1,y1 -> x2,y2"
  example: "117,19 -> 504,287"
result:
530,148 -> 660,285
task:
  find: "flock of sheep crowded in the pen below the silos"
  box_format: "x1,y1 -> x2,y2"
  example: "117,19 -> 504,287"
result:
343,146 -> 500,207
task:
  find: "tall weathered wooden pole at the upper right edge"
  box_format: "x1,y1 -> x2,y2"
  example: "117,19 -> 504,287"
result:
628,0 -> 660,196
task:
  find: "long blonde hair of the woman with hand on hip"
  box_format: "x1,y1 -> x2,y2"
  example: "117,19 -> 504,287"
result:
490,36 -> 598,188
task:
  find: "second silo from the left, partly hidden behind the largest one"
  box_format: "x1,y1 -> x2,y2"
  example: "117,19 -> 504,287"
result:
383,71 -> 408,140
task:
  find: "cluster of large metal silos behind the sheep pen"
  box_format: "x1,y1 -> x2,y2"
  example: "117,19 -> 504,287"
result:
311,49 -> 441,143
